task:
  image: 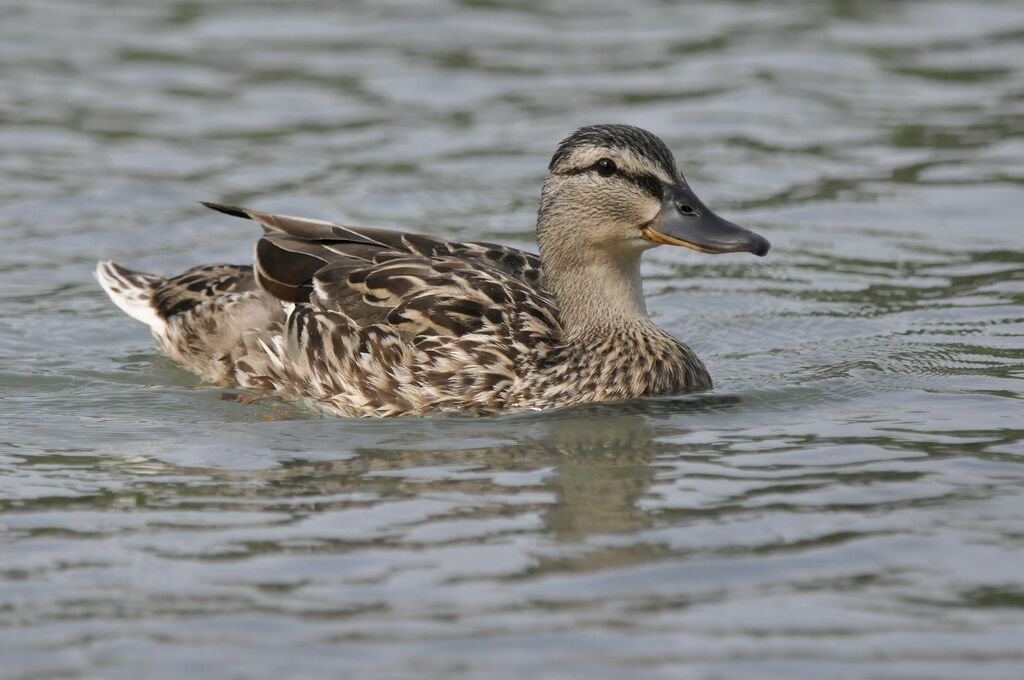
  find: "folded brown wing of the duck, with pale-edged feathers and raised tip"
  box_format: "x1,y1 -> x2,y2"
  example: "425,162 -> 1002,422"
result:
199,204 -> 560,366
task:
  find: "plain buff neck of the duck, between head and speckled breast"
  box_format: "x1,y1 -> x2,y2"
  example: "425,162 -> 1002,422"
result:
539,229 -> 650,340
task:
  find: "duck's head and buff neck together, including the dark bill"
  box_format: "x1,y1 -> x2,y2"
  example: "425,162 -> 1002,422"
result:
537,125 -> 771,335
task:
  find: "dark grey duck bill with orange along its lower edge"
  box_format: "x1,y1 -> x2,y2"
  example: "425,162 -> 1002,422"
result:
643,185 -> 771,257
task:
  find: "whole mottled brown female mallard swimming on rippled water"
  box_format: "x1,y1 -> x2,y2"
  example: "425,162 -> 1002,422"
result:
96,125 -> 770,416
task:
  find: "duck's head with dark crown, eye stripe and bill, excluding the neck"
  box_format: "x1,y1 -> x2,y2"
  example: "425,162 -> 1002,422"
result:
538,125 -> 771,256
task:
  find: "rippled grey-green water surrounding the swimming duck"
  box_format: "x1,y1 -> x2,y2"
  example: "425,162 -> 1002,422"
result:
0,0 -> 1024,679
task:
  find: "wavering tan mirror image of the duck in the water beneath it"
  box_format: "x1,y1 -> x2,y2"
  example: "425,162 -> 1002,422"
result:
97,405 -> 688,542
